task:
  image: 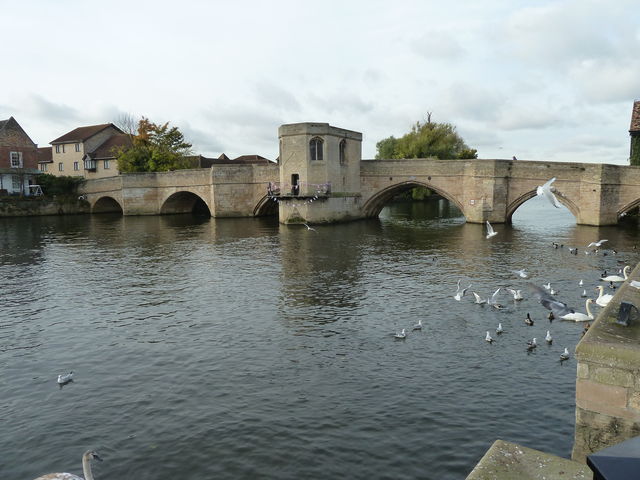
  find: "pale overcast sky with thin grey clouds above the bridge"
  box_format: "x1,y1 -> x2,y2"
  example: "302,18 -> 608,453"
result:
0,0 -> 640,164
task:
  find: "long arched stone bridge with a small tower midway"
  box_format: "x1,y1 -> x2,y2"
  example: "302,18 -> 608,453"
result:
81,123 -> 640,225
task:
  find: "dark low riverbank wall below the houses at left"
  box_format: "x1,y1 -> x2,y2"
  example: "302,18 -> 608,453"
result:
0,197 -> 91,217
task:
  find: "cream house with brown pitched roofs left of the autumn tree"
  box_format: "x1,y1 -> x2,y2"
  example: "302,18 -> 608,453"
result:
48,123 -> 131,178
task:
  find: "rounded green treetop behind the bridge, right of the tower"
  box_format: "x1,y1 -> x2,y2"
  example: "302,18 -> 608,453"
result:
376,116 -> 478,159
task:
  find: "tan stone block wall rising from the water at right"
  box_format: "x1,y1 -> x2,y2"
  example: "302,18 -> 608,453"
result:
572,265 -> 640,462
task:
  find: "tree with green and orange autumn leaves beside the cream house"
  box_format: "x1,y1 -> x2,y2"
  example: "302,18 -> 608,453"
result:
116,117 -> 191,173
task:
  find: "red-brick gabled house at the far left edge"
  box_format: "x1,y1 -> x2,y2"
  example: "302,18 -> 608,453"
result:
0,117 -> 38,195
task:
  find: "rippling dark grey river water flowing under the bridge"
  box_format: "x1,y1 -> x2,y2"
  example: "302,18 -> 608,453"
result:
0,198 -> 638,480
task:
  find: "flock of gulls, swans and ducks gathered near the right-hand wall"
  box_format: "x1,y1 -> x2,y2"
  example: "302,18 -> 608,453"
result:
394,178 -> 640,362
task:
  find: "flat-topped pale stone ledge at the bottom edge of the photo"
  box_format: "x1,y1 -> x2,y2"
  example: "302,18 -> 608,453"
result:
467,440 -> 593,480
